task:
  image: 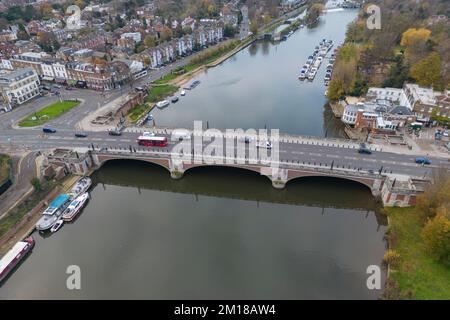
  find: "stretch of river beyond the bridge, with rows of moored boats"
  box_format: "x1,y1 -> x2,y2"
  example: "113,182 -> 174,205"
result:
152,10 -> 357,137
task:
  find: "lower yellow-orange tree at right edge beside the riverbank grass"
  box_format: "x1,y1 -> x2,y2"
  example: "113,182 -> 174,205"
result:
422,207 -> 450,266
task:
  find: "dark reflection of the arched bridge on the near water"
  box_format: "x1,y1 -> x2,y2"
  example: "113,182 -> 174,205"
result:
92,160 -> 387,226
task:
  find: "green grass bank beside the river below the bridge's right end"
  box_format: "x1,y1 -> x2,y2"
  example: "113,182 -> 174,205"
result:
385,208 -> 450,299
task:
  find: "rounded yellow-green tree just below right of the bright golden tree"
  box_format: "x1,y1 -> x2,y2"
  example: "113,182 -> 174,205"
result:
410,52 -> 441,88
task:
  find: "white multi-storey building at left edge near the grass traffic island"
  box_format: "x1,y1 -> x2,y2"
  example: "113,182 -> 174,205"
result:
0,68 -> 40,109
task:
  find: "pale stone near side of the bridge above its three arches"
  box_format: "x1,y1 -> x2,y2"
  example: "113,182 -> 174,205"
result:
44,147 -> 426,205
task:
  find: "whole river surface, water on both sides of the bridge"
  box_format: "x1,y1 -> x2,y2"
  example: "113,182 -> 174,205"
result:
0,12 -> 386,299
